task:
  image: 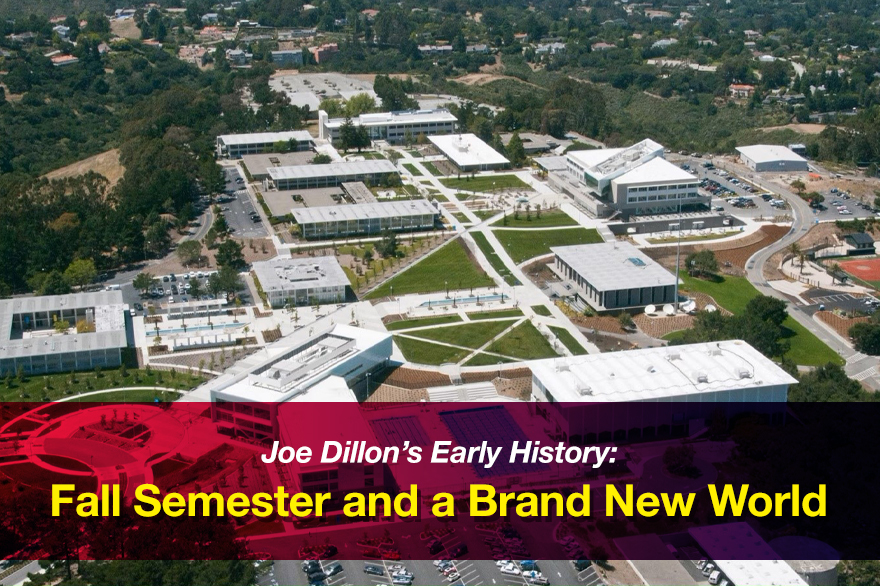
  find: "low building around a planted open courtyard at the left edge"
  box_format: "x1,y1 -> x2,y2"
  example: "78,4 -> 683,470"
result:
0,291 -> 128,376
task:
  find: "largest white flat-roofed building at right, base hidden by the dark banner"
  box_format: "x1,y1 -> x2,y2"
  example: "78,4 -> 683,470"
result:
529,340 -> 797,440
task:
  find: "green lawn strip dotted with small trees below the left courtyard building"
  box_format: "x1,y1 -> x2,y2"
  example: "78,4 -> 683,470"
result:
0,369 -> 203,401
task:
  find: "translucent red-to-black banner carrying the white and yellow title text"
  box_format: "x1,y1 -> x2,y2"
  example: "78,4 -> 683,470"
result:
0,402 -> 880,560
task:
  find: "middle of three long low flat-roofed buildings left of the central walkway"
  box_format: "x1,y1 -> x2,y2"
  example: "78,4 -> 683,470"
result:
268,159 -> 400,190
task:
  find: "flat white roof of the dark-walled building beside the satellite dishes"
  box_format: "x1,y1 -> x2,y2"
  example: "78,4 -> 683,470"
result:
550,241 -> 675,291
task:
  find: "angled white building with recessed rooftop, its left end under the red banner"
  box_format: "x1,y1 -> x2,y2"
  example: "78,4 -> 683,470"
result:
210,324 -> 393,439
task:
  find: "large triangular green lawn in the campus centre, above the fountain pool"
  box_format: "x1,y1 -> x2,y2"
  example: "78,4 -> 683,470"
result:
366,239 -> 494,299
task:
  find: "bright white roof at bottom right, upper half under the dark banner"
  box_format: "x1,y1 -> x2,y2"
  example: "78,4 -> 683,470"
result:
688,523 -> 806,586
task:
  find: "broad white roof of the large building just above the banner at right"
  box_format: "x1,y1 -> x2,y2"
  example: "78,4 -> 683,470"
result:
529,340 -> 797,402
